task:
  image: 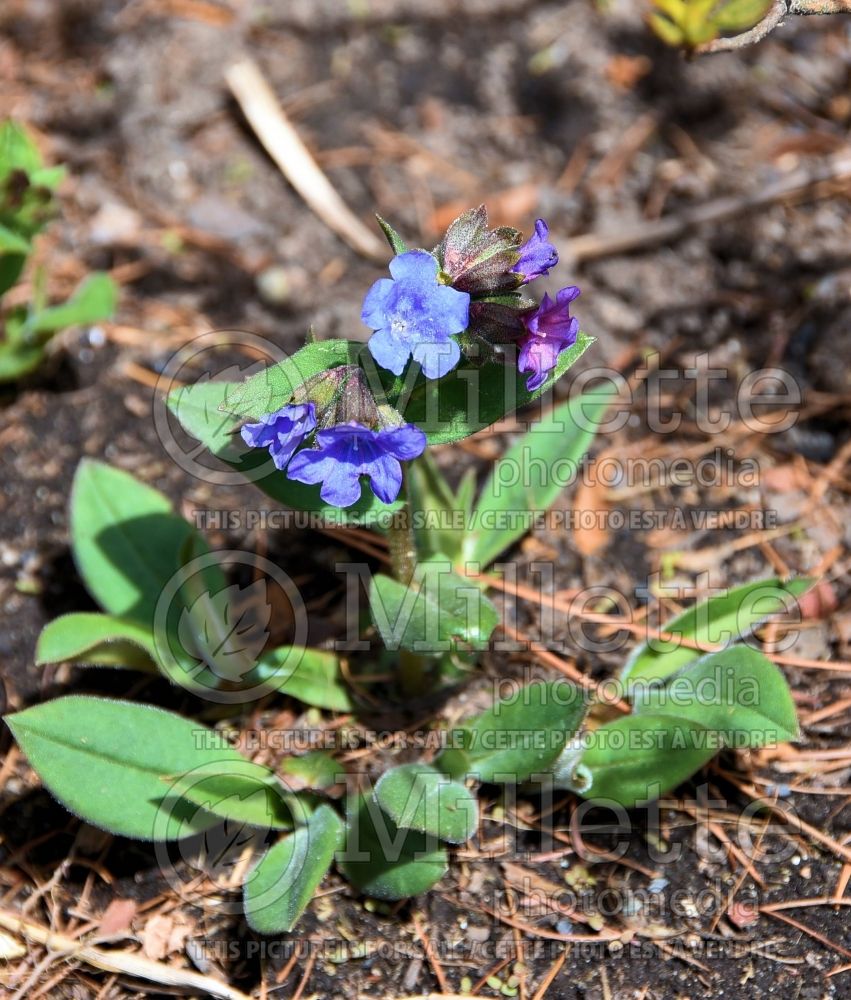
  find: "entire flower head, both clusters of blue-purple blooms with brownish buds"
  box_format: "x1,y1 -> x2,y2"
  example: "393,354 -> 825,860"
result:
241,206 -> 579,507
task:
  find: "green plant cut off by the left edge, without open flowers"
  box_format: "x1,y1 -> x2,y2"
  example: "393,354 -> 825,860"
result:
0,122 -> 116,382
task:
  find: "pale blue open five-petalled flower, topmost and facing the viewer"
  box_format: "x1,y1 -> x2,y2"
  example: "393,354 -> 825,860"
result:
361,250 -> 470,378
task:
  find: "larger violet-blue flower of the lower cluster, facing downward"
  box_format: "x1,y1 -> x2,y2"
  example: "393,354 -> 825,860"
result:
287,422 -> 426,507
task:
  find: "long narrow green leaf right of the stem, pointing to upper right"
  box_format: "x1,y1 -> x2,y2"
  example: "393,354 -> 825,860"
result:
464,384 -> 611,567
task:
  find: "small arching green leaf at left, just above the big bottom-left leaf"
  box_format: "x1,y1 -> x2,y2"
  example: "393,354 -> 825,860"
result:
35,612 -> 156,670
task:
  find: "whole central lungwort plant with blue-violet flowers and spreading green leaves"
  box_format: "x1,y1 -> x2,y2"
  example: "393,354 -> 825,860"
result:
8,208 -> 808,933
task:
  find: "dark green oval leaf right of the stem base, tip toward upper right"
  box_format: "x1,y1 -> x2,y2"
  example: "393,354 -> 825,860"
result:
435,680 -> 587,783
